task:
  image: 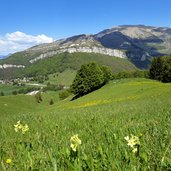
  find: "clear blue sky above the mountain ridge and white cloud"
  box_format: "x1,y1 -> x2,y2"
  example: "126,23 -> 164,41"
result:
0,0 -> 171,54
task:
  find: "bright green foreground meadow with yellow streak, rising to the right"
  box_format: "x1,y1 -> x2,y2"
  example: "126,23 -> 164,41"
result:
0,79 -> 171,171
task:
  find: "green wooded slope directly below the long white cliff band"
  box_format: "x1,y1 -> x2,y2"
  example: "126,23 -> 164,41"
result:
0,53 -> 136,77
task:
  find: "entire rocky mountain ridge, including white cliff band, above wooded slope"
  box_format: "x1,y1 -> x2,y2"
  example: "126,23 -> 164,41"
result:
0,25 -> 171,79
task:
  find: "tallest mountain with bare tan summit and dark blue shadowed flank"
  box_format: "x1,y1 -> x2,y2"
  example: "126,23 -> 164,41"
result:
95,25 -> 171,68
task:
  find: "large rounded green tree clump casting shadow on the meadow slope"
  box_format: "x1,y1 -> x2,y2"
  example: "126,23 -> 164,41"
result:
71,62 -> 112,97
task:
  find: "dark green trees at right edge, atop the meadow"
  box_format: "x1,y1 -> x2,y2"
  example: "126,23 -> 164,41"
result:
149,56 -> 171,83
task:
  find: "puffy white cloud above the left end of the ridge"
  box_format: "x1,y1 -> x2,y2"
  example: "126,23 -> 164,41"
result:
0,31 -> 54,55
